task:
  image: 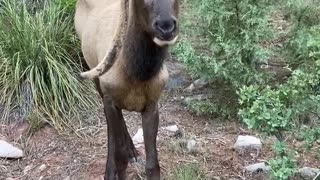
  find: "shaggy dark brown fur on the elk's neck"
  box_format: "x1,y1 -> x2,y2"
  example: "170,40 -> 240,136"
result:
123,1 -> 168,81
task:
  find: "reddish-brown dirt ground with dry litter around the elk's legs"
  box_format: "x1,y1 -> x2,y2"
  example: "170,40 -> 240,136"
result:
0,59 -> 314,180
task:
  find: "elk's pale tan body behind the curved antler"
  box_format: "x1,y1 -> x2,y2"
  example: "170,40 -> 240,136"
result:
75,0 -> 121,68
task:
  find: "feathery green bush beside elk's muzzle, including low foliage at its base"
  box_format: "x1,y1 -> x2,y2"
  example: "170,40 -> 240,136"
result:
173,0 -> 272,117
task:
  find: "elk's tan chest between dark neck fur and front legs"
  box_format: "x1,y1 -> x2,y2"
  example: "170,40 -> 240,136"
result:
100,63 -> 169,112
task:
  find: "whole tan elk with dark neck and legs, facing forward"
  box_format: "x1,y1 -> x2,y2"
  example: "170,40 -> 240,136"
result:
75,0 -> 179,180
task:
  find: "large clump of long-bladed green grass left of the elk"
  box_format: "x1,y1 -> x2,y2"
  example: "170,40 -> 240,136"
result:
0,0 -> 97,130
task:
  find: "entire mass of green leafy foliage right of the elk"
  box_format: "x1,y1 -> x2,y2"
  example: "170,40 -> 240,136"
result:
178,0 -> 320,179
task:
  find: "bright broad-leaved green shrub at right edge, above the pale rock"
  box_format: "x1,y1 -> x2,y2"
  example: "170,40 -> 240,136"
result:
239,25 -> 320,139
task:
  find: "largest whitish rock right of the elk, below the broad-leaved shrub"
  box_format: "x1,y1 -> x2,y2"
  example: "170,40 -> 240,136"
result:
233,135 -> 262,151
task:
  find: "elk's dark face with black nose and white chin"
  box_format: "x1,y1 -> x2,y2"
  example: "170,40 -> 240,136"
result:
134,0 -> 179,46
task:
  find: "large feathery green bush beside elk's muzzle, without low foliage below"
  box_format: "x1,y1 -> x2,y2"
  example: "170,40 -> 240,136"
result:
175,0 -> 271,87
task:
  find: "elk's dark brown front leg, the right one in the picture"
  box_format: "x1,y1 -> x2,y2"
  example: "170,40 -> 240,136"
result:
142,102 -> 160,180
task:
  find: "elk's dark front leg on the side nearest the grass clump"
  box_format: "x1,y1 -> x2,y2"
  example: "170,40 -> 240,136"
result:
103,96 -> 128,180
